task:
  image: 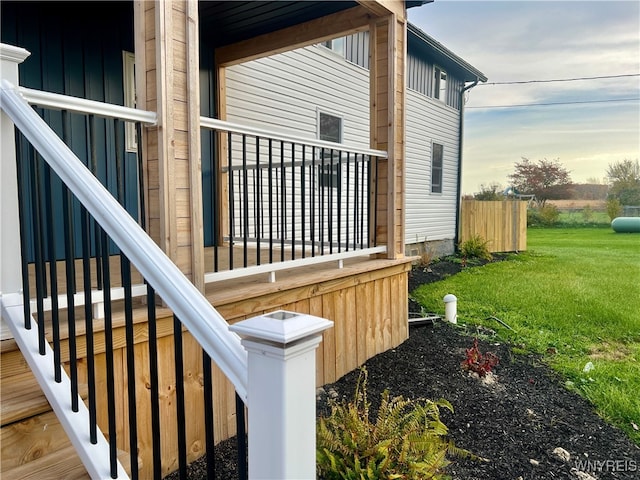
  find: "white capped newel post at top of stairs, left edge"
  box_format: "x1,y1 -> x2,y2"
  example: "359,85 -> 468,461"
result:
0,43 -> 31,295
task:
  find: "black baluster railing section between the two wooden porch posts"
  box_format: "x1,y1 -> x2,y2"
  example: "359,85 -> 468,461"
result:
203,125 -> 379,272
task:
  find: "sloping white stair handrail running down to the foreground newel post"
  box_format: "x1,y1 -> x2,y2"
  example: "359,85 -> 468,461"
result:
0,80 -> 247,400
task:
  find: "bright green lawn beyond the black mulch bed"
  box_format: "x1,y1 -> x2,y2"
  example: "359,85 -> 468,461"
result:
412,226 -> 640,445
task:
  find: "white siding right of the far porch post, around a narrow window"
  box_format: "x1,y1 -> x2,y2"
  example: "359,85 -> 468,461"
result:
405,90 -> 460,245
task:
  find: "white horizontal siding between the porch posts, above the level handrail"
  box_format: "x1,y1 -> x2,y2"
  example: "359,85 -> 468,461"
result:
226,46 -> 369,146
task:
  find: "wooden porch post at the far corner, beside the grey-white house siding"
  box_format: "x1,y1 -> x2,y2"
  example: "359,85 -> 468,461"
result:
369,9 -> 406,259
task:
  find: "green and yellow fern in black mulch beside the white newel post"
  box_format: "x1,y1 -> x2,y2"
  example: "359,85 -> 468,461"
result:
316,368 -> 484,480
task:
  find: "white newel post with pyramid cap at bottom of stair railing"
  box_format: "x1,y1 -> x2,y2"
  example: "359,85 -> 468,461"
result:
230,310 -> 333,480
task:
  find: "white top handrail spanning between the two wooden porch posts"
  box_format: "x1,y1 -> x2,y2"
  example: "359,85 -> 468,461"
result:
200,117 -> 387,158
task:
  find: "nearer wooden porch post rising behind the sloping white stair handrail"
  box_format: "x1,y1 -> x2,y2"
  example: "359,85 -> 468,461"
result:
134,0 -> 204,290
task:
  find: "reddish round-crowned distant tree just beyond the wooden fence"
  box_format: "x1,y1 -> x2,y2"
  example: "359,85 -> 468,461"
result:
509,157 -> 572,207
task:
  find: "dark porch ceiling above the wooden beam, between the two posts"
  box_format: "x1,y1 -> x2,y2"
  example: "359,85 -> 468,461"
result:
198,0 -> 358,48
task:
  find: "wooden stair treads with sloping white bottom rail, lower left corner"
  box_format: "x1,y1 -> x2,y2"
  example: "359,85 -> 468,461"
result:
0,297 -> 131,480
